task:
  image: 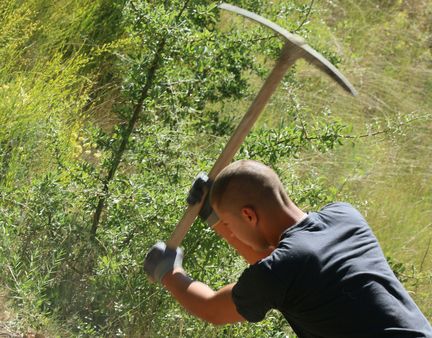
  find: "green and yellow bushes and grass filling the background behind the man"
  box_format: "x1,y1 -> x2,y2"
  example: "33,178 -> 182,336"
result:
0,0 -> 432,337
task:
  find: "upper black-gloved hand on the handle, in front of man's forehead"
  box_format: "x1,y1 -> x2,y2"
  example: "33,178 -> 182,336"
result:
186,173 -> 219,227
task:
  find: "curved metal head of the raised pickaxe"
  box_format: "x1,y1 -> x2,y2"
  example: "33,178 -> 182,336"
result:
218,3 -> 357,96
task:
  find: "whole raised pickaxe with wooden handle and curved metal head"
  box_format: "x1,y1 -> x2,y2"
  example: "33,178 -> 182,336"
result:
167,3 -> 357,249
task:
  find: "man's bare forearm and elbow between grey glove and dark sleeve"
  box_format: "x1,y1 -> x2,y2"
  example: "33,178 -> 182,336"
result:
162,268 -> 245,325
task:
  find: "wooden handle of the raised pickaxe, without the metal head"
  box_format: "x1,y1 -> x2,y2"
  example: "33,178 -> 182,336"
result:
167,42 -> 303,249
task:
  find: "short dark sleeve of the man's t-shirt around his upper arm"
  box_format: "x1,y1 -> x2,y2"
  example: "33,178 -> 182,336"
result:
232,263 -> 285,322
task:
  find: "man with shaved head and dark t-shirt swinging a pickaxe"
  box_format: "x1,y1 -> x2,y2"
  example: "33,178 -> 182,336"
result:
145,161 -> 432,338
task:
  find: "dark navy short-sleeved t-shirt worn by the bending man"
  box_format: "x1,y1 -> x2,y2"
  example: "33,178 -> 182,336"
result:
232,203 -> 432,338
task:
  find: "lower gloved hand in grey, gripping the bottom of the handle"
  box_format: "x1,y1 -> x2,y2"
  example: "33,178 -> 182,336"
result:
144,242 -> 183,282
